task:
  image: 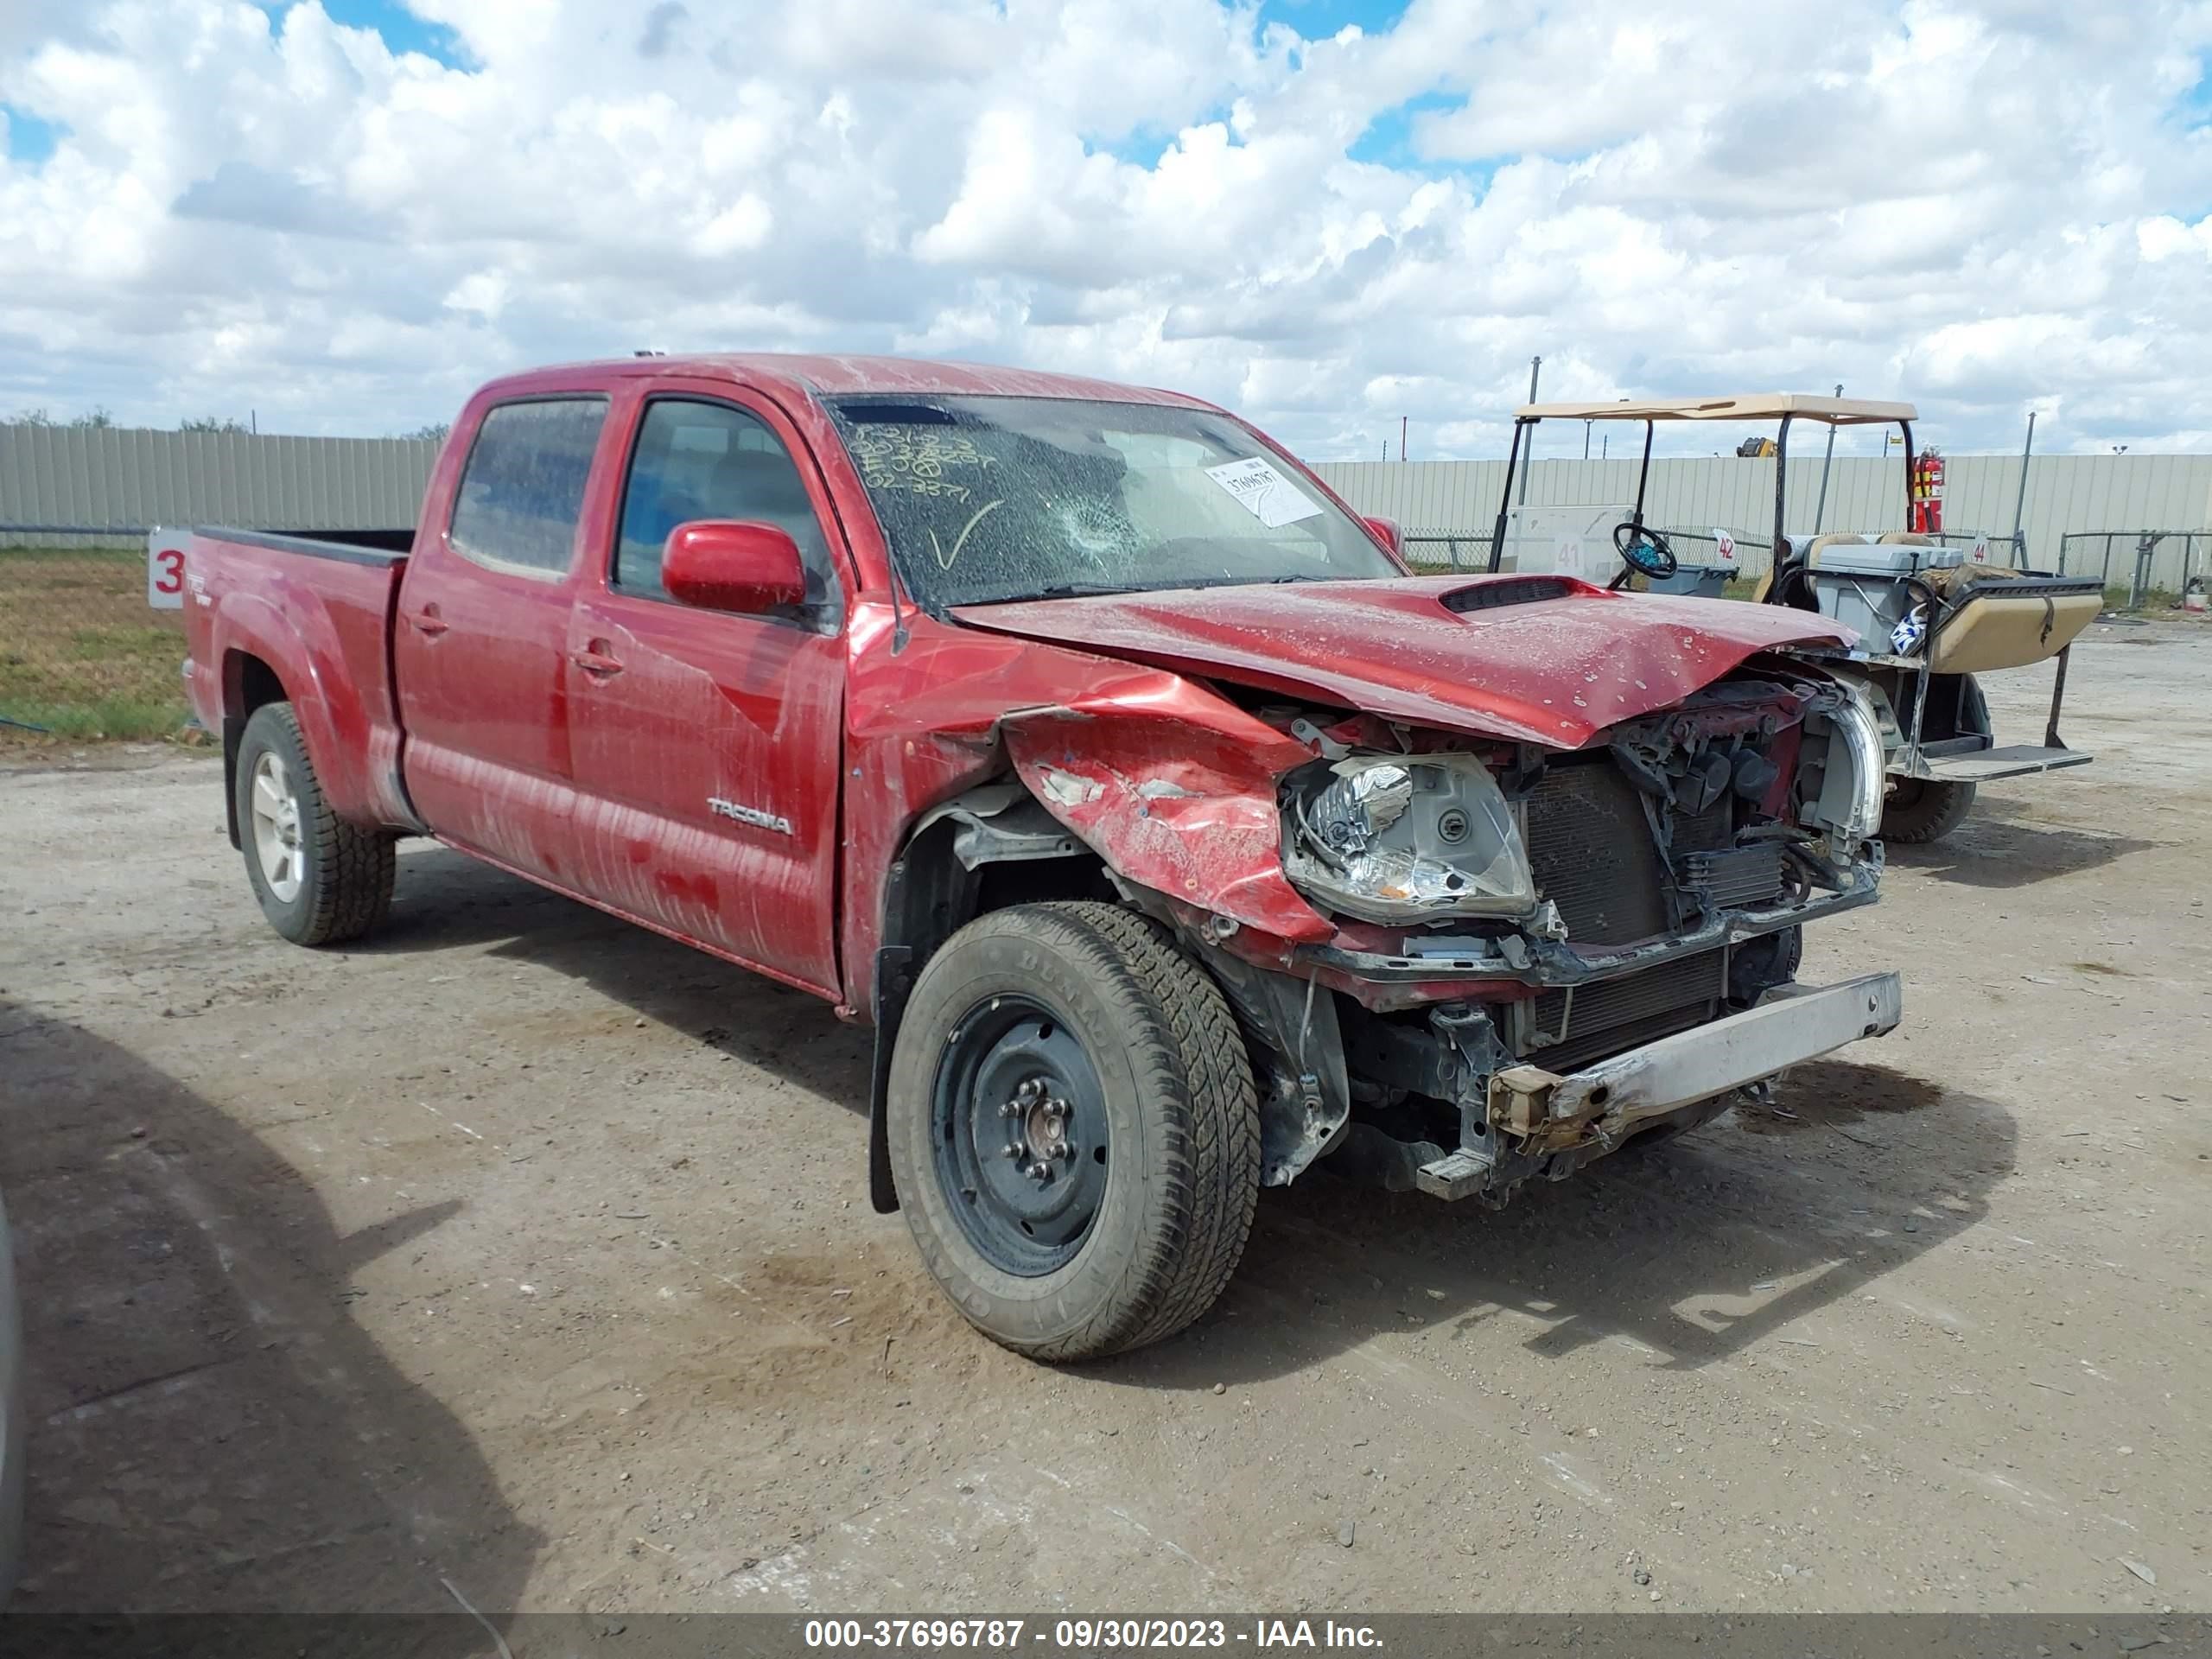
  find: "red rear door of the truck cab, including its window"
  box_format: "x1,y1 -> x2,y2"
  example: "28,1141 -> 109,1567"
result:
391,391 -> 613,887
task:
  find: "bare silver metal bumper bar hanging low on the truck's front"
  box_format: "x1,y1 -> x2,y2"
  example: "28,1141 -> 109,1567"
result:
1418,973 -> 1904,1199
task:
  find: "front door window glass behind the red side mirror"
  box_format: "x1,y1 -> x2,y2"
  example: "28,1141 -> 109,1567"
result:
613,398 -> 830,604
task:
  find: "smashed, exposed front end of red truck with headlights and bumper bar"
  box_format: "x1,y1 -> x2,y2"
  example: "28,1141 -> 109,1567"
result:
1015,655 -> 1900,1204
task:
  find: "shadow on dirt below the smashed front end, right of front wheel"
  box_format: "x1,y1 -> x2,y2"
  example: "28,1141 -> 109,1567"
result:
1110,1062 -> 2018,1389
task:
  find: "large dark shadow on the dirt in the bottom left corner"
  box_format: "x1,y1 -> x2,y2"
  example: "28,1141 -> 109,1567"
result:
0,1002 -> 540,1655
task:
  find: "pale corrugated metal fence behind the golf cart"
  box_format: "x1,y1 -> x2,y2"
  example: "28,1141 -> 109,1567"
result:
1314,455 -> 2212,591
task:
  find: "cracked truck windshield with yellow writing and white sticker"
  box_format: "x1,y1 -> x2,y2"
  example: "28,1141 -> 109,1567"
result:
830,396 -> 1402,611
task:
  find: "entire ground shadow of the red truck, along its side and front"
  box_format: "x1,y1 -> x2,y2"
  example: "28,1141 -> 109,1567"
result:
321,852 -> 2018,1389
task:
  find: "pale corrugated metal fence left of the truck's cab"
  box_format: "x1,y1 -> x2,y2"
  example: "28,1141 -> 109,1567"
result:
0,425 -> 438,546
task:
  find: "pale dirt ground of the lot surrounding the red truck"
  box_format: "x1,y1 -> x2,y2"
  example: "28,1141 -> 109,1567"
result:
0,624 -> 2212,1612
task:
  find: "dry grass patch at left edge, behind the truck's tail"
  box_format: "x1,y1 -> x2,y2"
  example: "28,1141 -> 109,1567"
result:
0,549 -> 188,743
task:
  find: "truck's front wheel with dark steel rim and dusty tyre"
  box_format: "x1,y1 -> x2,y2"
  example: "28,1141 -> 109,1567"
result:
887,902 -> 1259,1360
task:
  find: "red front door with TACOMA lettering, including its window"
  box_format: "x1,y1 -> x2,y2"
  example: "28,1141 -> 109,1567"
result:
566,383 -> 845,995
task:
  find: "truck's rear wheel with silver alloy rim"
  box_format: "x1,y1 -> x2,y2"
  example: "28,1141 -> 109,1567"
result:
232,703 -> 394,944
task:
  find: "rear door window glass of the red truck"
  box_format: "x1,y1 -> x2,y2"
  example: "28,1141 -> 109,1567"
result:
447,398 -> 606,575
